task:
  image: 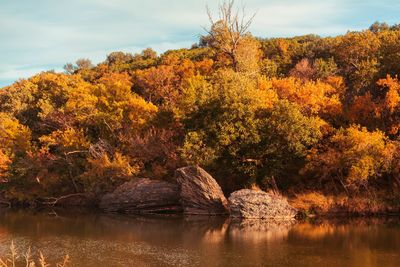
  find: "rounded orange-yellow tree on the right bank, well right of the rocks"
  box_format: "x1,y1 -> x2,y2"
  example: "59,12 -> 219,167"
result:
306,125 -> 395,193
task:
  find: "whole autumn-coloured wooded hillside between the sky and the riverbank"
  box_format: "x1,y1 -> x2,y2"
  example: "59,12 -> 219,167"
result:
0,3 -> 400,204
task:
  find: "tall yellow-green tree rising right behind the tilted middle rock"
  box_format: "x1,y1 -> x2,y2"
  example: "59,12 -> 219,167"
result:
181,69 -> 268,191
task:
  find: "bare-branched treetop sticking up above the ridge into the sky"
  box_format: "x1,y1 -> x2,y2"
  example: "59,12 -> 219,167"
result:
205,0 -> 256,71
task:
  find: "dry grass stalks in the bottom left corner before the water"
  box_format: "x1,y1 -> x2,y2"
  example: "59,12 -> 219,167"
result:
0,241 -> 69,267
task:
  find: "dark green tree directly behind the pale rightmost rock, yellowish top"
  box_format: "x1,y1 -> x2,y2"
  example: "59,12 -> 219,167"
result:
253,100 -> 326,189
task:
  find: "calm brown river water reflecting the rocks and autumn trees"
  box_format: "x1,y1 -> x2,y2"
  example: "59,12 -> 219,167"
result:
0,211 -> 400,267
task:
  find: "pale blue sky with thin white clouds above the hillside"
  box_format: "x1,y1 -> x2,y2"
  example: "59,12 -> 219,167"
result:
0,0 -> 400,87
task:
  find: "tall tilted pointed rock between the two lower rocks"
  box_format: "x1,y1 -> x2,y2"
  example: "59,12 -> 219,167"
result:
175,166 -> 229,215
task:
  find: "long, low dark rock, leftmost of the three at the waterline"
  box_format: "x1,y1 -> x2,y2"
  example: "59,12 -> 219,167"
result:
100,178 -> 182,213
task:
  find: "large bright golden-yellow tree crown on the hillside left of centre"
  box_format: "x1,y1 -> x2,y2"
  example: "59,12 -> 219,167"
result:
65,74 -> 158,130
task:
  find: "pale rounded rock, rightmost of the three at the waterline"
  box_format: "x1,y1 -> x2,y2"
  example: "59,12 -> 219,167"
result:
229,189 -> 297,220
